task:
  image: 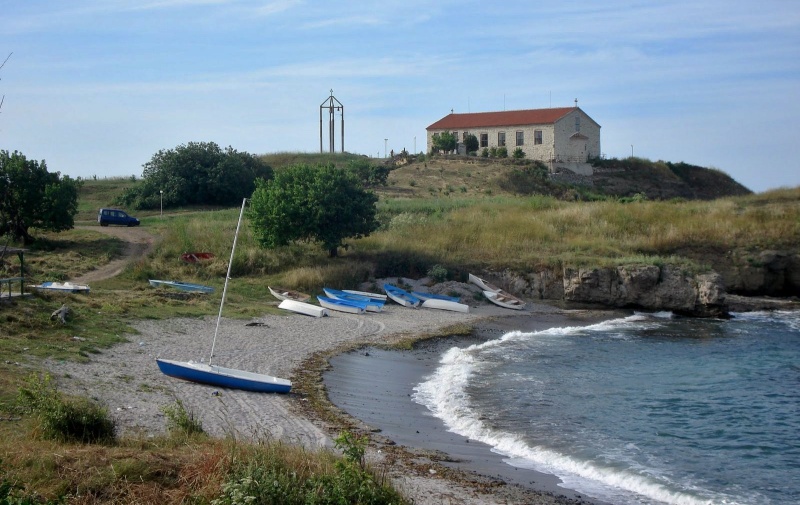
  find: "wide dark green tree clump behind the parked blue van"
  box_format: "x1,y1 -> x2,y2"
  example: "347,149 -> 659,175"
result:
119,142 -> 272,209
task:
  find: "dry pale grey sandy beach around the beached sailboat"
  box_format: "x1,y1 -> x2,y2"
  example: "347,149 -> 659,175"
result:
46,286 -> 612,505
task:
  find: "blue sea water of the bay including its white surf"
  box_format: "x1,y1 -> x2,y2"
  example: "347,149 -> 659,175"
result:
413,312 -> 800,504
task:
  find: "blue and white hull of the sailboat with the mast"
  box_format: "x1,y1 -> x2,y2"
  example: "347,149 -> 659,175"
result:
156,358 -> 292,393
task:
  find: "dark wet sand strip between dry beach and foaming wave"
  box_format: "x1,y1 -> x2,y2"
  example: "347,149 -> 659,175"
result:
323,311 -> 615,505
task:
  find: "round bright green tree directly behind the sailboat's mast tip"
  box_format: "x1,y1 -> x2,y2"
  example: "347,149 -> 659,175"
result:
249,164 -> 378,257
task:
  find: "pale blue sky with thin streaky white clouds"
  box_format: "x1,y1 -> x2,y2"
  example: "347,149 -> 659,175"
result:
0,0 -> 800,192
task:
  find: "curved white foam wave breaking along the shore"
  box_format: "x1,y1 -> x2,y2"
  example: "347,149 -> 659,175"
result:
413,315 -> 752,505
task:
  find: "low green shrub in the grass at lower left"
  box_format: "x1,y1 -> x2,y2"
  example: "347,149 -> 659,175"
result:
17,374 -> 116,443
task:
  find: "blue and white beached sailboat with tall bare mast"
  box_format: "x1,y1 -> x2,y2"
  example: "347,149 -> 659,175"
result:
156,198 -> 292,393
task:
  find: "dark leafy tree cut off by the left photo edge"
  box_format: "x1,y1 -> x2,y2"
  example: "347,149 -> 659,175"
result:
0,151 -> 81,245
